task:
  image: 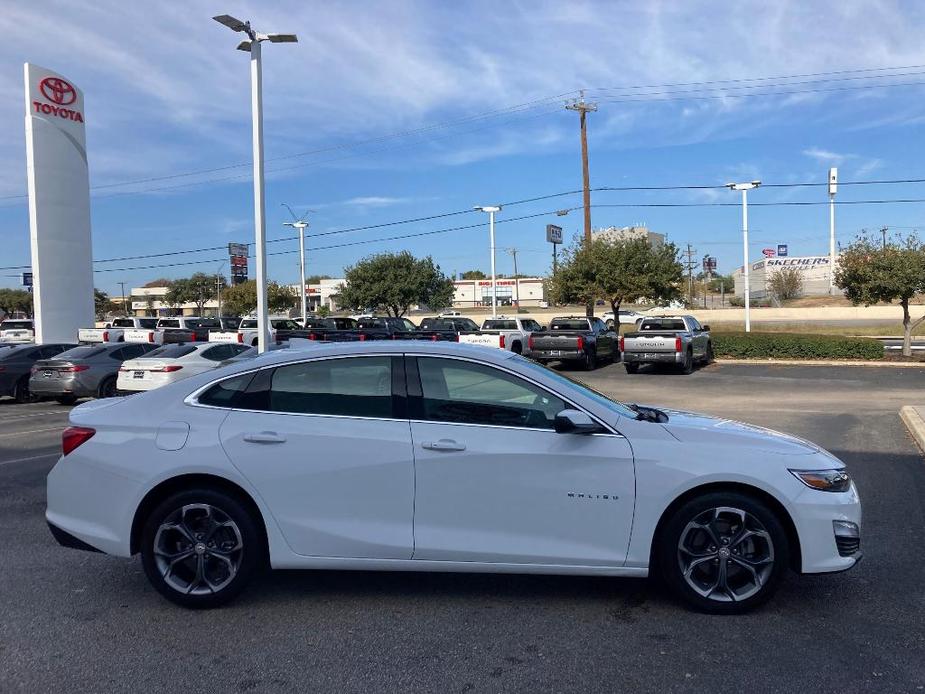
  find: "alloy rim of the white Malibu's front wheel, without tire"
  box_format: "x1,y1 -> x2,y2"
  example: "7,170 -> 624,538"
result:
678,506 -> 774,602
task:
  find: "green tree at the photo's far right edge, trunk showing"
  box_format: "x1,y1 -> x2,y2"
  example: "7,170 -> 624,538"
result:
835,235 -> 925,357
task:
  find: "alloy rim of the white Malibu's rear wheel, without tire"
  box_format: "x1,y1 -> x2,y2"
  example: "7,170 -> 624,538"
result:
154,504 -> 244,595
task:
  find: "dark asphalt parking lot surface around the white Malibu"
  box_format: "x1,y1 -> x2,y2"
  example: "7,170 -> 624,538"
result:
0,364 -> 925,692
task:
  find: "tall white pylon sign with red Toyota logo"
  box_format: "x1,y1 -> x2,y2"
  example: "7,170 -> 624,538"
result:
23,63 -> 95,344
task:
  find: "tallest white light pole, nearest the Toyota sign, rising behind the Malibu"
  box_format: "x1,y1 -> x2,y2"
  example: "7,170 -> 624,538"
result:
212,14 -> 299,353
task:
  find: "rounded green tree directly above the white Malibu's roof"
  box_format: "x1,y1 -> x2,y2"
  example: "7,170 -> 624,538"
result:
338,251 -> 454,316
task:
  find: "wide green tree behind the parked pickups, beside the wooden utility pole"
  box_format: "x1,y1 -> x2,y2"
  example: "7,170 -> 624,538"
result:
548,238 -> 684,332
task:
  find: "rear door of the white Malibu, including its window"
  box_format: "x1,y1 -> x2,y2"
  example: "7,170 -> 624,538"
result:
220,355 -> 414,559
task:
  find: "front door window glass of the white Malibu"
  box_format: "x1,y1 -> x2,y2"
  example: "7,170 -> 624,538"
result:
415,357 -> 567,429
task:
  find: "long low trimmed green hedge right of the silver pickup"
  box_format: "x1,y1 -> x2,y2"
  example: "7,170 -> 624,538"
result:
712,333 -> 883,360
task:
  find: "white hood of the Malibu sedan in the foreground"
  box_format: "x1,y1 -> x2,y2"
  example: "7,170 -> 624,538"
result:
660,408 -> 822,455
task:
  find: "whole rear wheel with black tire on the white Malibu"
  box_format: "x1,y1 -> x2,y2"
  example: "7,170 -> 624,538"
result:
141,488 -> 268,609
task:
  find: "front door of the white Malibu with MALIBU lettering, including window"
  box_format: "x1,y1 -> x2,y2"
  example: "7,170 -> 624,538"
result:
408,357 -> 635,566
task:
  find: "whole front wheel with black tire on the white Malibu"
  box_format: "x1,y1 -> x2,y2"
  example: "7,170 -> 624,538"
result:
653,491 -> 790,614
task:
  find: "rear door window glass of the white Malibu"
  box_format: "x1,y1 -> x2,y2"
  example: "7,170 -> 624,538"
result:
267,357 -> 392,418
